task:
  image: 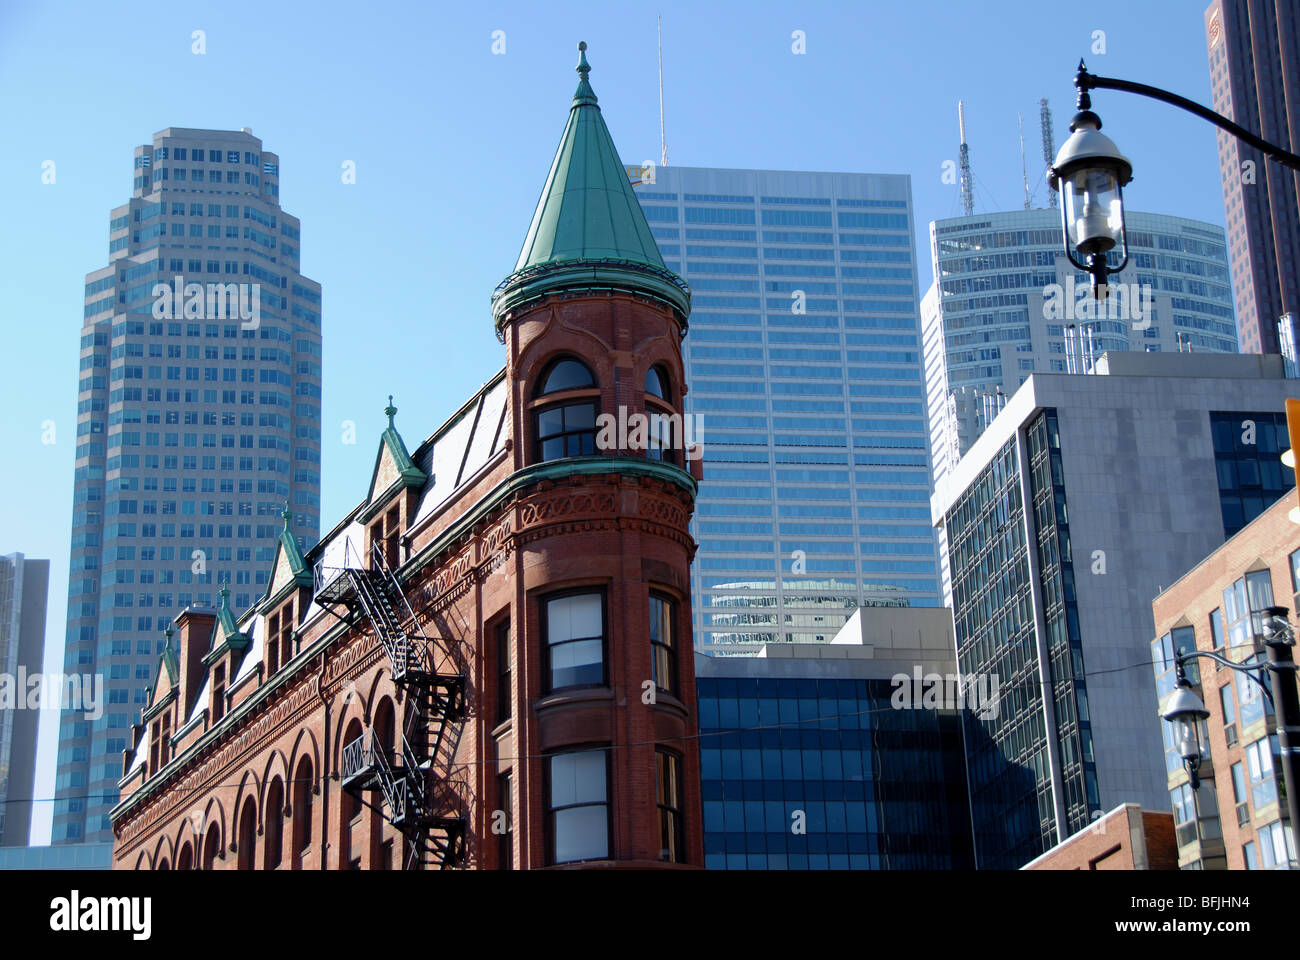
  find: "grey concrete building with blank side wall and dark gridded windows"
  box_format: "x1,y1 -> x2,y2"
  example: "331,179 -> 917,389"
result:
931,353 -> 1296,868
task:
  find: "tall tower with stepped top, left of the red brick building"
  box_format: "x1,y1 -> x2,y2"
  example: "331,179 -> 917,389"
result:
53,127 -> 321,843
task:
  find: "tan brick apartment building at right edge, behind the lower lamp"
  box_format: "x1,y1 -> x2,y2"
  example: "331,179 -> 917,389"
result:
1152,486 -> 1300,870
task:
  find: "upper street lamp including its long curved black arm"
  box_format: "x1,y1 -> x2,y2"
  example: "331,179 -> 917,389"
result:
1048,60 -> 1300,300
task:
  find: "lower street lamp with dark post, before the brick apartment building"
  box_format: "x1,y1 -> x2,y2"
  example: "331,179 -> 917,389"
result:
1161,606 -> 1300,868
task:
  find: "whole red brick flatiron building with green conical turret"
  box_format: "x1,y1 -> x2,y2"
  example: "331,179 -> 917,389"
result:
113,44 -> 703,869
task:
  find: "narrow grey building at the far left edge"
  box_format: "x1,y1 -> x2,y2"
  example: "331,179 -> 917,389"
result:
0,553 -> 49,847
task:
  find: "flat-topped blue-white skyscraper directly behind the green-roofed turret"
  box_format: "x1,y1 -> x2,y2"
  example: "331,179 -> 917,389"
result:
628,167 -> 940,654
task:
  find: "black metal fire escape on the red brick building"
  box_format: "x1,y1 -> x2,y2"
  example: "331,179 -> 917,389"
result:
315,542 -> 465,869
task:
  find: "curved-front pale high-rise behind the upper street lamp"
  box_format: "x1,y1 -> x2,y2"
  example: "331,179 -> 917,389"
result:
920,209 -> 1236,480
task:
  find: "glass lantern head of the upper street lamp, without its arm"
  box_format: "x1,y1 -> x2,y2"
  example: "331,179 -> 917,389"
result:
1048,60 -> 1134,300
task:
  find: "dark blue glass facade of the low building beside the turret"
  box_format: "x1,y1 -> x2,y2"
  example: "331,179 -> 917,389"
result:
697,670 -> 974,870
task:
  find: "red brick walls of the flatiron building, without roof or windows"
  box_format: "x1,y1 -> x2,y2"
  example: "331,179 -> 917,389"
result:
114,282 -> 703,869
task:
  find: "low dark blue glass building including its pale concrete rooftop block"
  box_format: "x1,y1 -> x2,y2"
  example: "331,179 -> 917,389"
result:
696,607 -> 974,870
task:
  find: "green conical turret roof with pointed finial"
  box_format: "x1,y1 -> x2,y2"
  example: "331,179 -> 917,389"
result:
493,43 -> 690,330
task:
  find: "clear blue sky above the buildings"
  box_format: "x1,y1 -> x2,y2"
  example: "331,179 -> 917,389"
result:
0,0 -> 1223,842
